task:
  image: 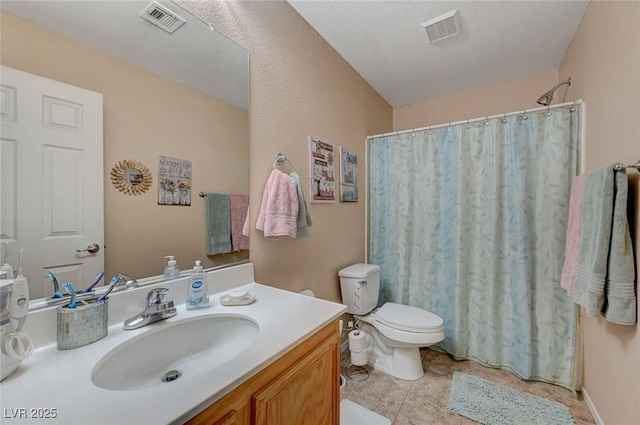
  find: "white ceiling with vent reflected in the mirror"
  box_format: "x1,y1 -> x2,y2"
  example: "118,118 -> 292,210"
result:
0,0 -> 249,109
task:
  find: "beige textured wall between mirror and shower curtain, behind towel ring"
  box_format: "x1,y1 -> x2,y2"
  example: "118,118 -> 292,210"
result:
179,1 -> 392,301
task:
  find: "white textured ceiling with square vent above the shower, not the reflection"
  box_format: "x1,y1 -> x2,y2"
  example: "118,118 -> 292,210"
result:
288,0 -> 589,107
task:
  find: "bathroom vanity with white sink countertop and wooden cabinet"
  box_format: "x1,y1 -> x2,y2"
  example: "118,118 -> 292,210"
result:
0,263 -> 345,425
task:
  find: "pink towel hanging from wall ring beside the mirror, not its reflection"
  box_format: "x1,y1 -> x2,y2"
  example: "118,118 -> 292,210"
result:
256,169 -> 298,239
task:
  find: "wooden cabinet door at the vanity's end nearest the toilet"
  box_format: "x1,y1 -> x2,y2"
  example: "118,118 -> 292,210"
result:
253,338 -> 340,425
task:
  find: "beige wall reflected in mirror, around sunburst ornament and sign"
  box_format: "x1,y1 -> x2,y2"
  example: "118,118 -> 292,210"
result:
1,12 -> 249,277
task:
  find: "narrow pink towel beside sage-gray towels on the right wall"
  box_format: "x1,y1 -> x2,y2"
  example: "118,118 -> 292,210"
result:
560,174 -> 587,296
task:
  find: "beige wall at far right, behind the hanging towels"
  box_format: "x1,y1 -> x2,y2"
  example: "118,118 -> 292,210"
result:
560,1 -> 640,425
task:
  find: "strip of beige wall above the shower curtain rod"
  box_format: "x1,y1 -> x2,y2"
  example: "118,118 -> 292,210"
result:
393,71 -> 556,131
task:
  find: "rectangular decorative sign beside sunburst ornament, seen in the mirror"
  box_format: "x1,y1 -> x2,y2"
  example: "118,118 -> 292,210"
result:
158,156 -> 191,205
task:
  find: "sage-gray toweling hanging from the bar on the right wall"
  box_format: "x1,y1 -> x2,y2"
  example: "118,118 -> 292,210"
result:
573,164 -> 636,324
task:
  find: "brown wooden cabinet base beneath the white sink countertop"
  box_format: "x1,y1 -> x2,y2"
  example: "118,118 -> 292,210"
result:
187,321 -> 340,425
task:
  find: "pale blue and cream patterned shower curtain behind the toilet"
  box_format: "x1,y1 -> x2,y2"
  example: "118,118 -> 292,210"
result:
368,108 -> 580,388
